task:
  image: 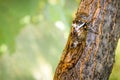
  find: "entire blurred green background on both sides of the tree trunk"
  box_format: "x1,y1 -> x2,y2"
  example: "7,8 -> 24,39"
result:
0,0 -> 120,80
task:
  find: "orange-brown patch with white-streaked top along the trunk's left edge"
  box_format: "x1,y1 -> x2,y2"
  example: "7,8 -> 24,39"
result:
54,19 -> 88,80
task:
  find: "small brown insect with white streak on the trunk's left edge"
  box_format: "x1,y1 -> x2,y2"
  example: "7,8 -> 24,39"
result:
72,20 -> 88,47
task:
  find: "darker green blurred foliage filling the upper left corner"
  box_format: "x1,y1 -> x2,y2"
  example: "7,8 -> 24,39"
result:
0,0 -> 38,51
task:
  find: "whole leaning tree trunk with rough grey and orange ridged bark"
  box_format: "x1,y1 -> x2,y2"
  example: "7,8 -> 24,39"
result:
54,0 -> 120,80
